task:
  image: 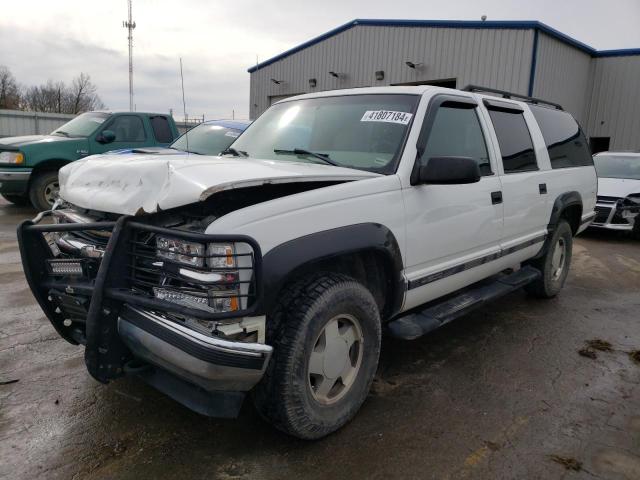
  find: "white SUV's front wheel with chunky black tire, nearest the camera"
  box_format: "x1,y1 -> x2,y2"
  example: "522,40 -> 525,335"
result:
253,273 -> 381,440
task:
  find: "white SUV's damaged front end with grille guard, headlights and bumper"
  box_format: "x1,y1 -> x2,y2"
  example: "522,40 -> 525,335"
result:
18,210 -> 272,417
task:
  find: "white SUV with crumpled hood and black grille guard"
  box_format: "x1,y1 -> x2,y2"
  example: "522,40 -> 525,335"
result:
18,86 -> 596,438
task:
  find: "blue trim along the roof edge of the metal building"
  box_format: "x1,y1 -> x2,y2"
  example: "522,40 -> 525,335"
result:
247,19 -> 640,73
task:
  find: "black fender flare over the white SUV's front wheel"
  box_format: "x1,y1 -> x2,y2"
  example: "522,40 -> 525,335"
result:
260,223 -> 406,317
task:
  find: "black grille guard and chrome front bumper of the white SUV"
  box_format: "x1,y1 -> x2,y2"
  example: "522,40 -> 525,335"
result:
18,217 -> 272,416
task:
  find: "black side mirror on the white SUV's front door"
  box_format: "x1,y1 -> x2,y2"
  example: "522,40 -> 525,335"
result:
415,157 -> 480,185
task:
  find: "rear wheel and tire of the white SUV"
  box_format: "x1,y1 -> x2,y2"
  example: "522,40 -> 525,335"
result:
525,220 -> 573,298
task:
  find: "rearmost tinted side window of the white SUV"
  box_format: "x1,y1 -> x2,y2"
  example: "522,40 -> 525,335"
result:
529,105 -> 593,168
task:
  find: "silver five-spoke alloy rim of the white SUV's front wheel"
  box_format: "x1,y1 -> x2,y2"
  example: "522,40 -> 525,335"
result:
307,314 -> 364,405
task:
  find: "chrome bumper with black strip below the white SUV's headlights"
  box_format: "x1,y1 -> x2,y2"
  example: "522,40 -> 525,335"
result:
118,306 -> 273,392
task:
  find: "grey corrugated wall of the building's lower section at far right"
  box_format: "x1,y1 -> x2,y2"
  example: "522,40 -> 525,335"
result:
586,55 -> 640,150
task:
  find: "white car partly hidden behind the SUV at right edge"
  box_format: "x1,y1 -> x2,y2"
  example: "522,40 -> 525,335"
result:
591,152 -> 640,237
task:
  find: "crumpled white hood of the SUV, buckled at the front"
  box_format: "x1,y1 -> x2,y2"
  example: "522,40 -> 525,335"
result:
59,154 -> 378,215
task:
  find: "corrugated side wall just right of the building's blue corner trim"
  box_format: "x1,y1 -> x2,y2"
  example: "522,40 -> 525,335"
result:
533,32 -> 594,125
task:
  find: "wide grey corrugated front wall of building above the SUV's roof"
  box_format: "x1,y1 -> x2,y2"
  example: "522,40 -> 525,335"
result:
250,26 -> 533,118
